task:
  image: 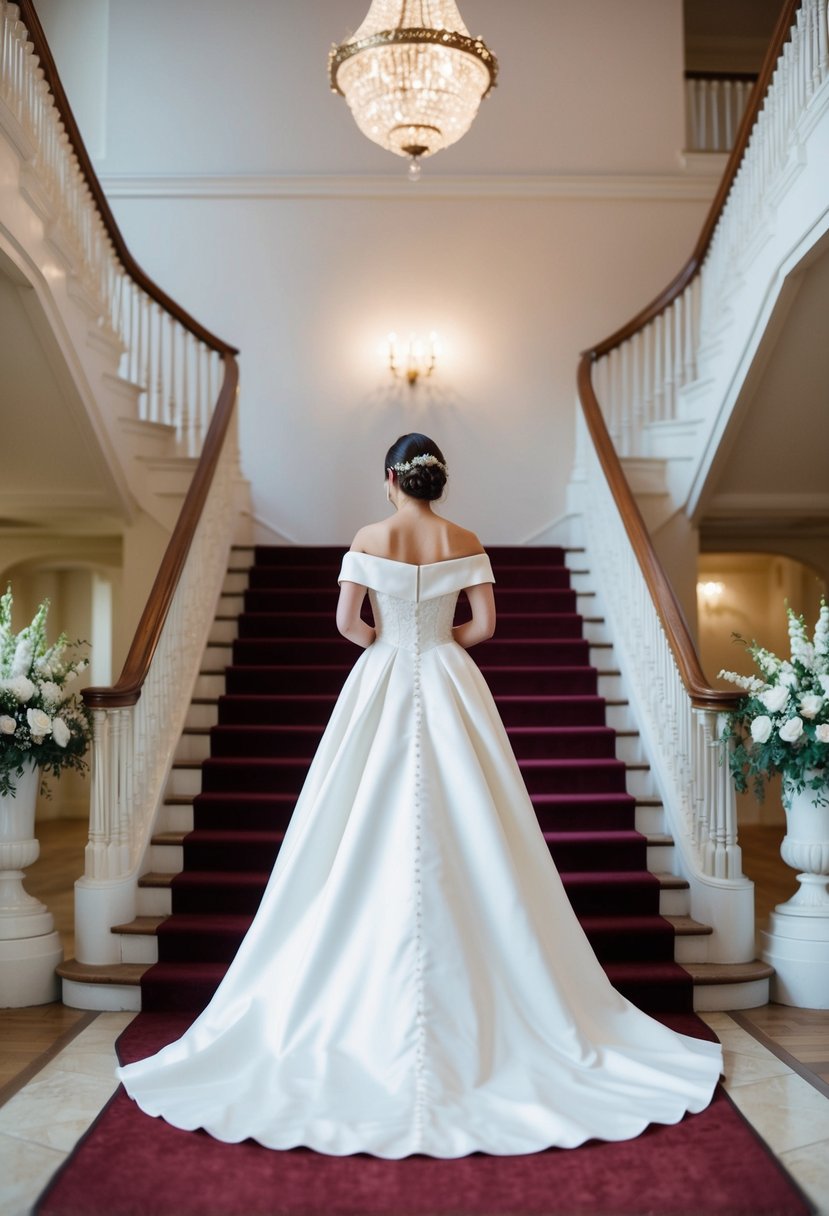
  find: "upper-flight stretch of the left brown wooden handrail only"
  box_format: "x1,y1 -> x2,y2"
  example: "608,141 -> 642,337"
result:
16,0 -> 238,355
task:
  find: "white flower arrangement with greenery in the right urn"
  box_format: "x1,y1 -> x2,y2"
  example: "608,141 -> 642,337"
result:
720,599 -> 829,804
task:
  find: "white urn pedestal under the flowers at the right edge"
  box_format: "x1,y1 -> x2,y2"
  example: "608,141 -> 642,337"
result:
761,771 -> 829,1009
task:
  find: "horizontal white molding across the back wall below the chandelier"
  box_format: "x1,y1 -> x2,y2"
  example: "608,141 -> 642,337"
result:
100,171 -> 721,203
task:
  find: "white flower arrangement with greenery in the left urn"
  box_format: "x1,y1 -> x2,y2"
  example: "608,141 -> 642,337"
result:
0,587 -> 91,795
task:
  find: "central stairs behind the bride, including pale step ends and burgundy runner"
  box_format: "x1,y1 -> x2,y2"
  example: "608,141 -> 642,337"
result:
61,547 -> 768,1013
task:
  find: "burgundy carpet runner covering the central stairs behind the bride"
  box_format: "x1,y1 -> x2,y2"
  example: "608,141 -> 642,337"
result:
142,547 -> 693,1013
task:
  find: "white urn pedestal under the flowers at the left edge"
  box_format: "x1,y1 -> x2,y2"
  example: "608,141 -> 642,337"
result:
0,765 -> 63,1008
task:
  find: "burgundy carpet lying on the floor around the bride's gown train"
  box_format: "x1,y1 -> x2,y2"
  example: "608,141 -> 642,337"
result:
35,1014 -> 813,1216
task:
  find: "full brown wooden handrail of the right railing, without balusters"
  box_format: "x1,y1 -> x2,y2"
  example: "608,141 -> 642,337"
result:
577,0 -> 800,710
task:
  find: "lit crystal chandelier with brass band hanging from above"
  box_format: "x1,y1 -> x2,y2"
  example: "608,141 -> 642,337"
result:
328,0 -> 498,181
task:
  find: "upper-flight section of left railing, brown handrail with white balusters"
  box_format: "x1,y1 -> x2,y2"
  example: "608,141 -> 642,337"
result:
0,0 -> 236,455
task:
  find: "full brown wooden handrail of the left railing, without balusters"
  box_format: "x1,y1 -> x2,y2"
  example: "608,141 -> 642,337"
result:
10,0 -> 238,709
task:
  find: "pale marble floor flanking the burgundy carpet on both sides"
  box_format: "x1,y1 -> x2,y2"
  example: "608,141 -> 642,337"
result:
0,1013 -> 829,1216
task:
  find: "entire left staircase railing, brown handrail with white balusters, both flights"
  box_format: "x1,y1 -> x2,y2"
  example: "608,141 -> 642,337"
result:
6,0 -> 239,963
